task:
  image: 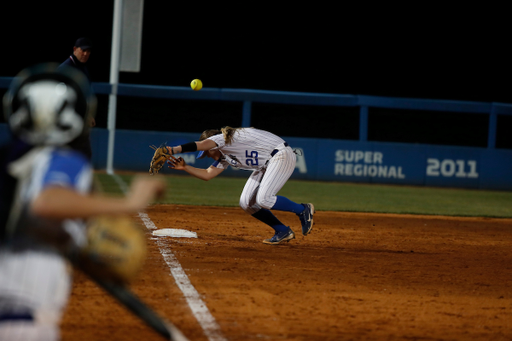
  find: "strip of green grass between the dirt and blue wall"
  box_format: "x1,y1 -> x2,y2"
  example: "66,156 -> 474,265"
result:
95,173 -> 512,218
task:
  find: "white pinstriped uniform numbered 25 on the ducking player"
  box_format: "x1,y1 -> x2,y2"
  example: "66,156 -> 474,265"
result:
209,128 -> 297,215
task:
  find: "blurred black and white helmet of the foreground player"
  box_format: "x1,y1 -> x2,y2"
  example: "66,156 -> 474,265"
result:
4,64 -> 95,145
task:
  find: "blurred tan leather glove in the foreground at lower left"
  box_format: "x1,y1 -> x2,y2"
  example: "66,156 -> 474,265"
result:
76,216 -> 147,284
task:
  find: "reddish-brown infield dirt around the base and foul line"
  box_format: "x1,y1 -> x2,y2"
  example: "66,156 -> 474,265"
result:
62,205 -> 512,341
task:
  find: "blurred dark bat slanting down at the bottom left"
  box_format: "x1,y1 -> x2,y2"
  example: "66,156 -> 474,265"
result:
84,271 -> 189,341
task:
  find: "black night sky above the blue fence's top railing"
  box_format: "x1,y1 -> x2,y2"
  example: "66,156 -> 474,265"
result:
0,0 -> 512,103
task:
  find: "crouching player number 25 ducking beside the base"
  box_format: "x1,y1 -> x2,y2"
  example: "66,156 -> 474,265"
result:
168,127 -> 315,244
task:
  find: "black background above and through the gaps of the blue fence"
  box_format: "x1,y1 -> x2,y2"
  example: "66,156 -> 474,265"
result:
0,0 -> 512,148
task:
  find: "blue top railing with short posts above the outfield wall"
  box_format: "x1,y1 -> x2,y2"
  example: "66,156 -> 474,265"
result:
0,77 -> 512,149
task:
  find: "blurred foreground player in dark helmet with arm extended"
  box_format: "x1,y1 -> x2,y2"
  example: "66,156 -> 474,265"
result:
0,64 -> 164,341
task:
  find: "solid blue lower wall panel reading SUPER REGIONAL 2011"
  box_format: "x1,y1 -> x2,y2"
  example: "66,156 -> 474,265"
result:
84,128 -> 512,190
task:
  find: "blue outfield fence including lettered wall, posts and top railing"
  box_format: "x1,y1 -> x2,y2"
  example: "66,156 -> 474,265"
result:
0,77 -> 512,190
